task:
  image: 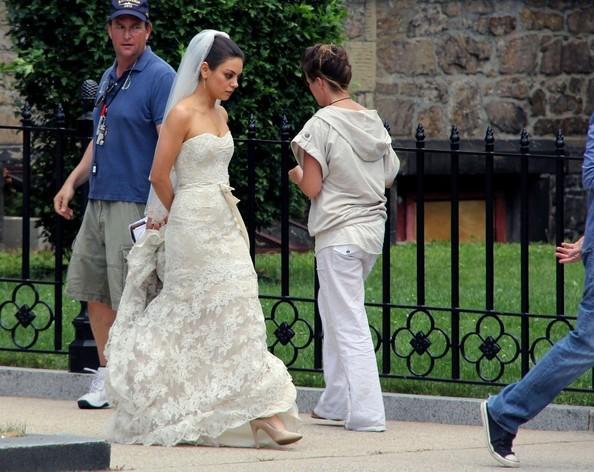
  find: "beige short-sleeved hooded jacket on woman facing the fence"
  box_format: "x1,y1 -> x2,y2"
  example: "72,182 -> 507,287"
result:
291,106 -> 400,254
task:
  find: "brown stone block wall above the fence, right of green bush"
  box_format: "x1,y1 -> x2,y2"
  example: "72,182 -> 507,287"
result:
347,0 -> 594,140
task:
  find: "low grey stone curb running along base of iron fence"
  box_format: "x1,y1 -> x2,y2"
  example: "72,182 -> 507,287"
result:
0,366 -> 594,431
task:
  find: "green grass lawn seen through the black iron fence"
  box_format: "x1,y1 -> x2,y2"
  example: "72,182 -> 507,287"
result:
0,243 -> 594,405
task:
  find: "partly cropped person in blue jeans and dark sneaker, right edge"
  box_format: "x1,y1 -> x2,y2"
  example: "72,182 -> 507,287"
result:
481,114 -> 594,467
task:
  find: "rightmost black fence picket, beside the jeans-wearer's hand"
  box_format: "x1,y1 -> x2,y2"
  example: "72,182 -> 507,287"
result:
555,130 -> 565,316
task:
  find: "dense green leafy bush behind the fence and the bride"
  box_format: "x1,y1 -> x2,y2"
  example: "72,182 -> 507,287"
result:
2,0 -> 346,249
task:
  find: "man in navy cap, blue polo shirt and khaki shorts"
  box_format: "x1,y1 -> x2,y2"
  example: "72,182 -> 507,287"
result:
54,0 -> 175,408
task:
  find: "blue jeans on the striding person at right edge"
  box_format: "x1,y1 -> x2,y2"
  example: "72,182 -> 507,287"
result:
488,251 -> 594,434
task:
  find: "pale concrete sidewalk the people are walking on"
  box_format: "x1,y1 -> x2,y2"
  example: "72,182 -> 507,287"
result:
0,397 -> 594,472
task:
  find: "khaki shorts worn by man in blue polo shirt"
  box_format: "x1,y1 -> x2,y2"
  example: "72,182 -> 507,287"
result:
66,200 -> 144,310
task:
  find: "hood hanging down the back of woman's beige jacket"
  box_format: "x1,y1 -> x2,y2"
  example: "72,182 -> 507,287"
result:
314,106 -> 392,162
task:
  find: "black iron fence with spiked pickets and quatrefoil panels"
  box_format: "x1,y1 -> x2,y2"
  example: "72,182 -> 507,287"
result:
0,104 -> 594,392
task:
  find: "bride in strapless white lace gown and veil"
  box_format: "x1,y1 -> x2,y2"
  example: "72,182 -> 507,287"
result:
106,30 -> 301,447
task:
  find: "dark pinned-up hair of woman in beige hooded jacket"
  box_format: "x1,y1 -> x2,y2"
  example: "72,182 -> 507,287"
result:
301,44 -> 353,90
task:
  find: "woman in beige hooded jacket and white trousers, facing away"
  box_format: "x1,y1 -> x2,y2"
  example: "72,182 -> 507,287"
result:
289,44 -> 399,431
